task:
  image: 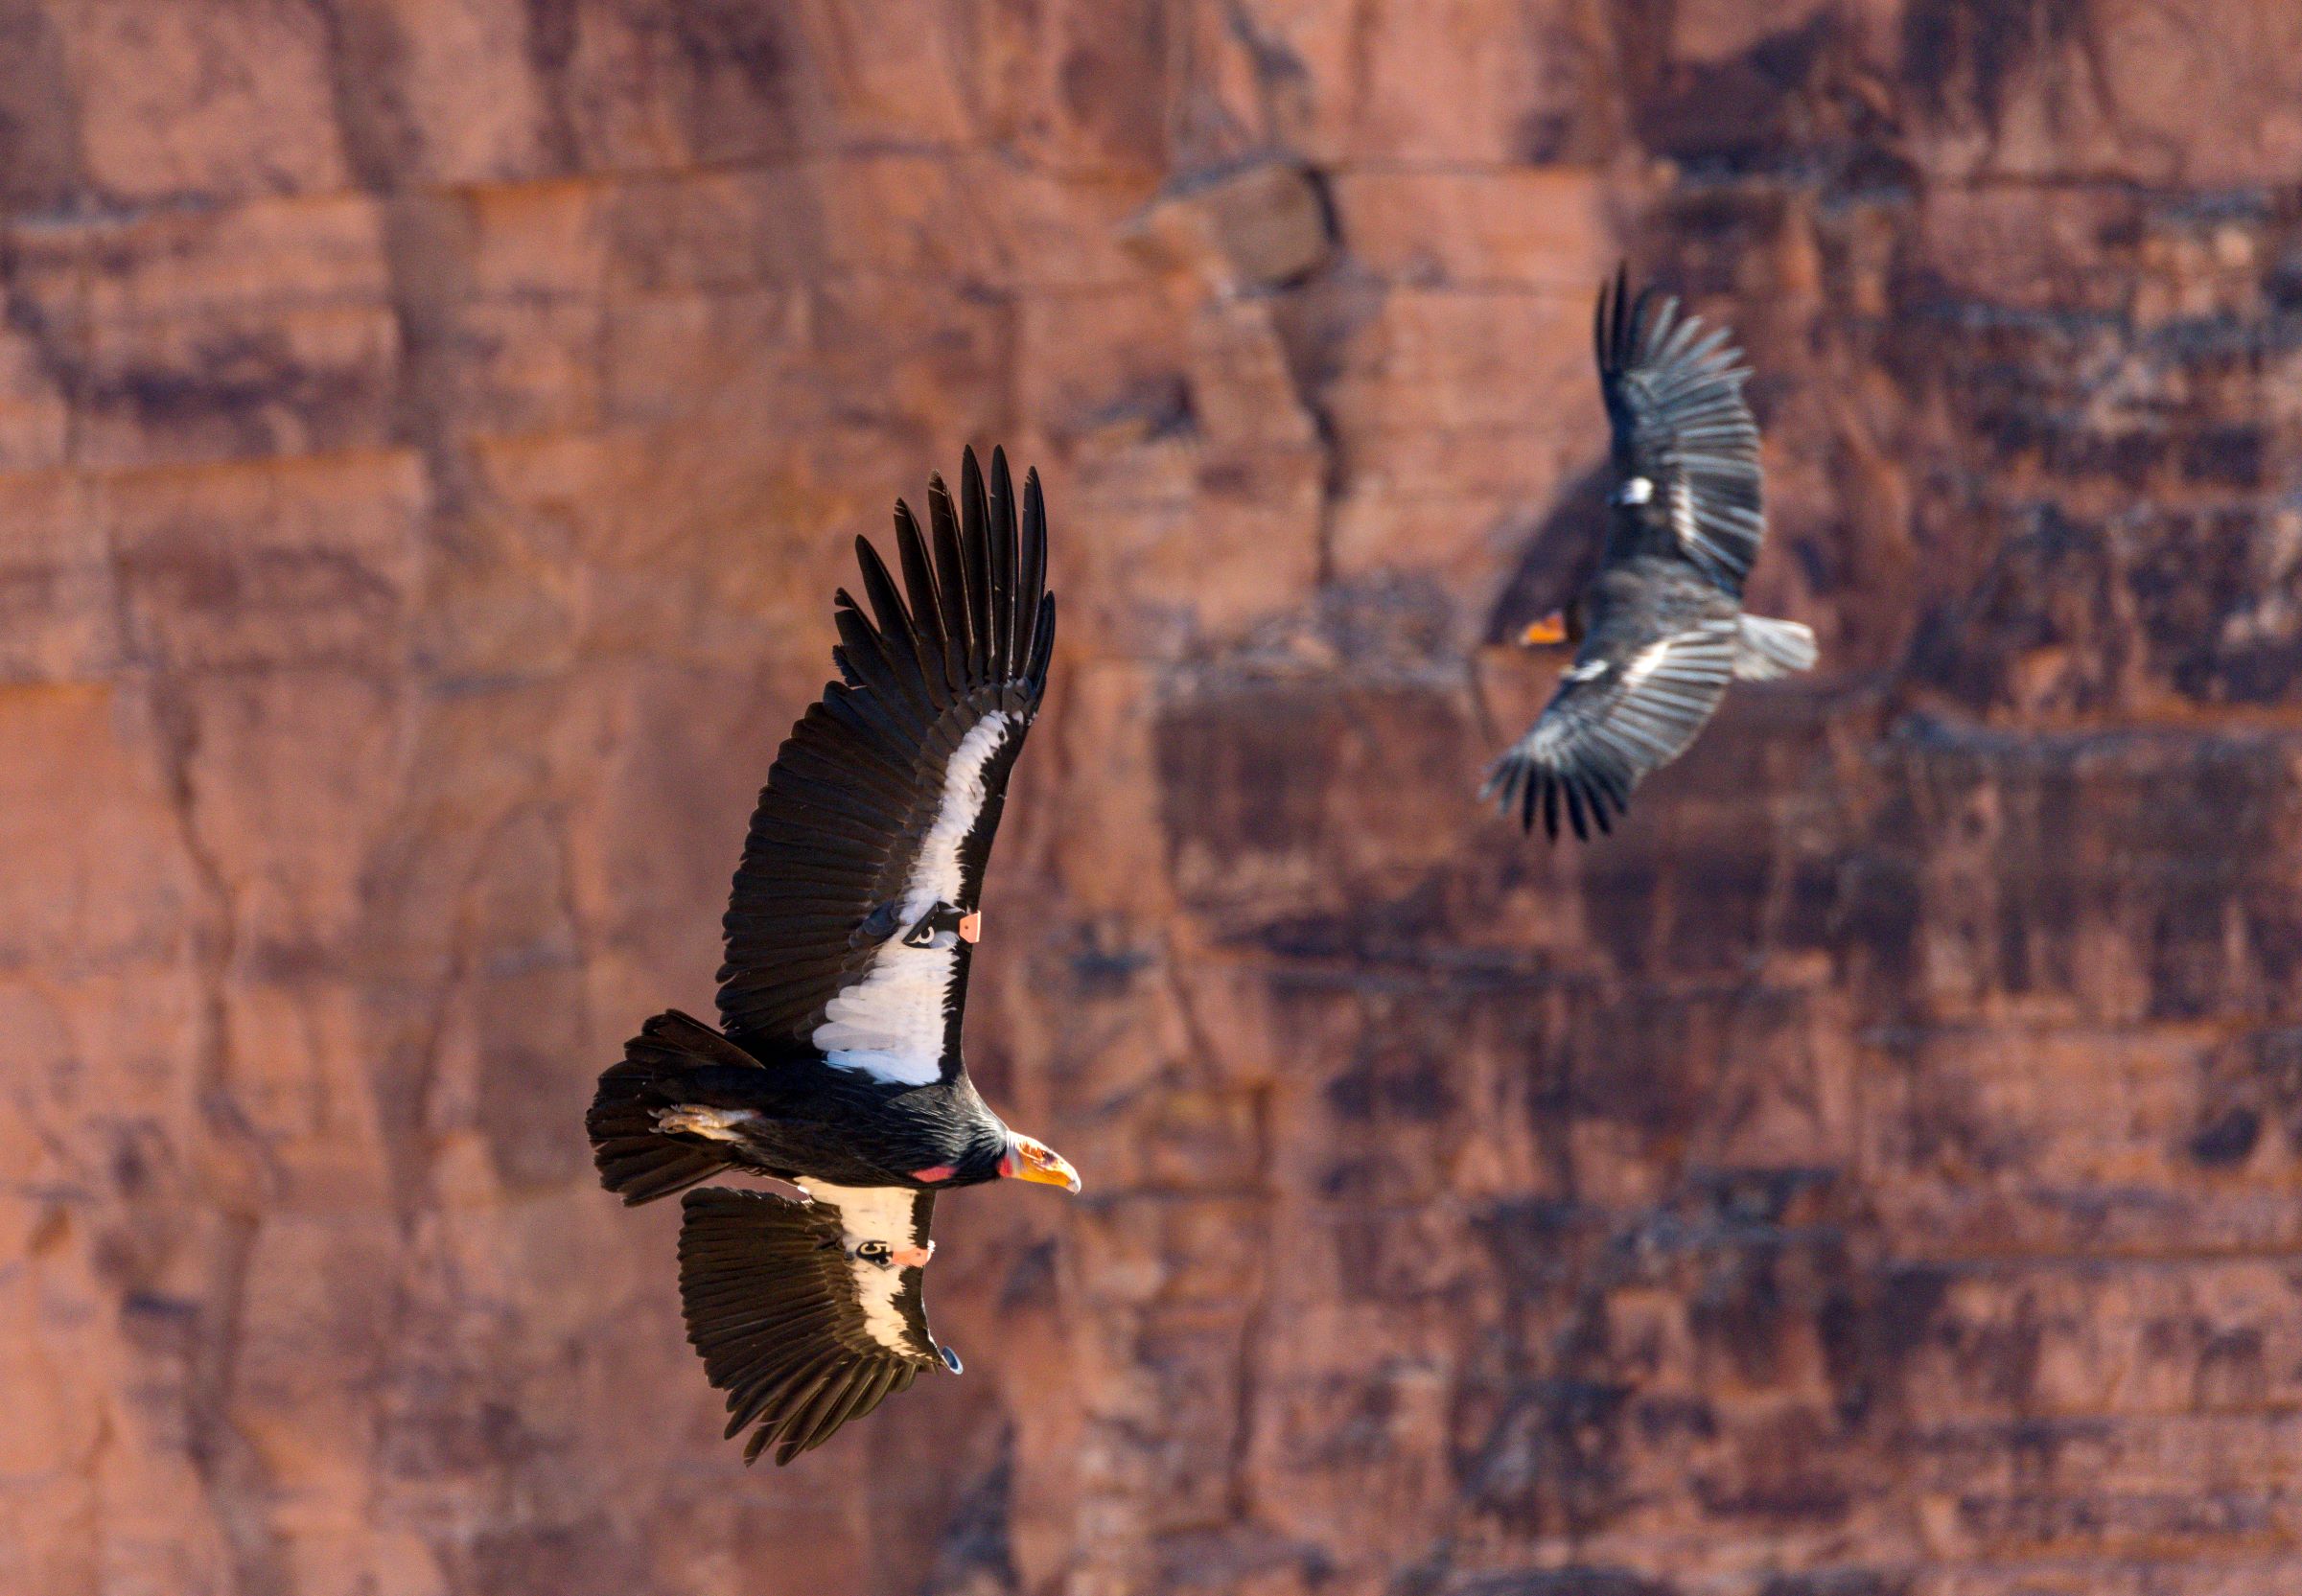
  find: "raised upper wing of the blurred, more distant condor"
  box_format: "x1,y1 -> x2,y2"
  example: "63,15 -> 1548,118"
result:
1595,272 -> 1766,594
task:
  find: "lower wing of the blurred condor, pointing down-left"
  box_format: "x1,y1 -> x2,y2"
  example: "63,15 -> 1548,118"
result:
1487,619 -> 1735,839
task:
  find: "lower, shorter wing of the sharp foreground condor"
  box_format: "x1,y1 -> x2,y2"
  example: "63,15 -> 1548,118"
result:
679,1182 -> 960,1465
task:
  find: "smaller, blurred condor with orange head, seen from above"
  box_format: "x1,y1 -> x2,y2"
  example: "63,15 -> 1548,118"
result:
1485,272 -> 1814,839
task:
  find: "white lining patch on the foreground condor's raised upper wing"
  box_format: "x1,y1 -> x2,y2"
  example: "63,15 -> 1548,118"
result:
810,709 -> 1015,1087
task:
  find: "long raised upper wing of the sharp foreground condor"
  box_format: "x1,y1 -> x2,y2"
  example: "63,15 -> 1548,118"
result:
718,450 -> 1055,1085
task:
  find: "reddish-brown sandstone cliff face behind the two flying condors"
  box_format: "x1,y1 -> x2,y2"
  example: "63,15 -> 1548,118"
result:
0,0 -> 2302,1596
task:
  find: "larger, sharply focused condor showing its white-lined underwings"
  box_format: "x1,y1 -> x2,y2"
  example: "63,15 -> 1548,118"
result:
587,451 -> 1080,1465
